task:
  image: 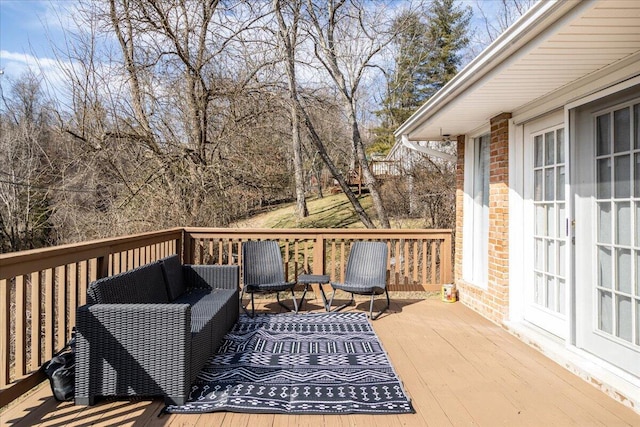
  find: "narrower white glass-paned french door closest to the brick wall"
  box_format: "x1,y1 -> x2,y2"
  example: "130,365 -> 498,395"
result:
524,116 -> 568,339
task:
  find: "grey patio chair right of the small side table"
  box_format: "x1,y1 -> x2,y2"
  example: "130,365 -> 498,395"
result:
327,242 -> 390,320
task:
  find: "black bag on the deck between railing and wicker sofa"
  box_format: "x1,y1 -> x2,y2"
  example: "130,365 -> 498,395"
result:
43,331 -> 76,402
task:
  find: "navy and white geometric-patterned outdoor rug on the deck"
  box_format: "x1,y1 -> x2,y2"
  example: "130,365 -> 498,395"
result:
165,313 -> 414,414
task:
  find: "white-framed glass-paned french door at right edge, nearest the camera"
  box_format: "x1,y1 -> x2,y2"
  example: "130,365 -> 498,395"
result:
575,97 -> 640,376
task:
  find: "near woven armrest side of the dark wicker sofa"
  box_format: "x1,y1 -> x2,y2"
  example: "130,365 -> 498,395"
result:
75,304 -> 191,404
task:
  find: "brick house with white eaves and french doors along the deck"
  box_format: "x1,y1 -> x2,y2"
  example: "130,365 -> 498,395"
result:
396,0 -> 640,412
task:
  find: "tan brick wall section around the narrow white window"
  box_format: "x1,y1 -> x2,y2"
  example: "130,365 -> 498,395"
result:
454,113 -> 511,323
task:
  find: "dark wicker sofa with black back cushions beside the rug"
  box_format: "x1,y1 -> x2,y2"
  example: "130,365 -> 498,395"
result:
75,256 -> 239,405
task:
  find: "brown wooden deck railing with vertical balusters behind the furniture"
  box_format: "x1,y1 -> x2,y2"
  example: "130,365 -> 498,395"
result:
0,228 -> 452,407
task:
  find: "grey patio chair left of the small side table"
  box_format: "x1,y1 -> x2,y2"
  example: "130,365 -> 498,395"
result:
240,240 -> 298,317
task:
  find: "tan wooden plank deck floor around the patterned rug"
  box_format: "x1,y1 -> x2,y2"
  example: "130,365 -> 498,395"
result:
0,299 -> 640,427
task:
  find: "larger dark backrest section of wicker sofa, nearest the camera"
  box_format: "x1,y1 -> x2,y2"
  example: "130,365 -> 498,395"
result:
87,261 -> 169,304
